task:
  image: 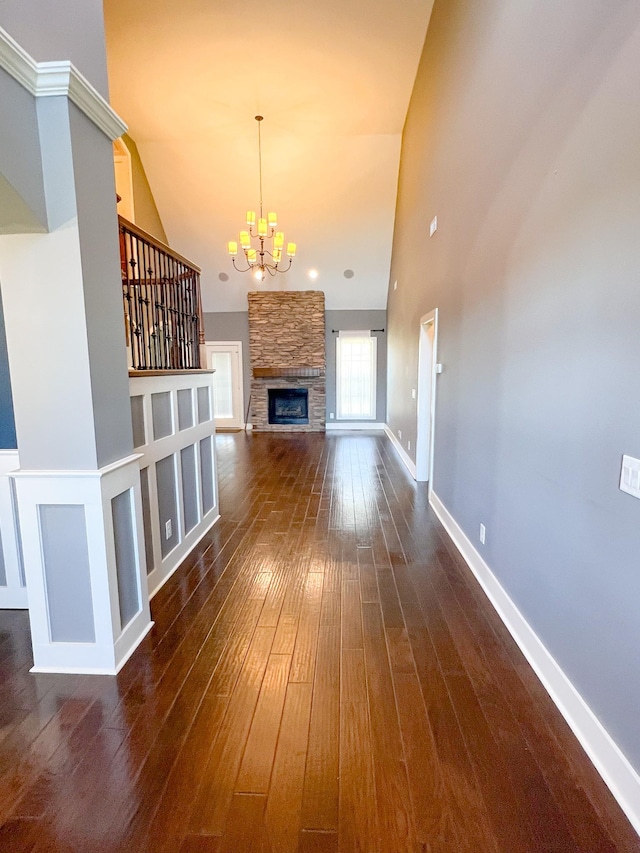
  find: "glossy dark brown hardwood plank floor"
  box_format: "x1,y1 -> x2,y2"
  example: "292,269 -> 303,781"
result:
0,433 -> 640,853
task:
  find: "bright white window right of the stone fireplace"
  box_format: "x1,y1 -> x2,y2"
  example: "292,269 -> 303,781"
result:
336,331 -> 377,421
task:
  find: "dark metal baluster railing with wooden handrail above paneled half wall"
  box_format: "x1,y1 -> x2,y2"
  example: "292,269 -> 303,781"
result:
118,216 -> 204,370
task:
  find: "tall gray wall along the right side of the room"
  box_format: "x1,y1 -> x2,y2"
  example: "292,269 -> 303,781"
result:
388,0 -> 640,770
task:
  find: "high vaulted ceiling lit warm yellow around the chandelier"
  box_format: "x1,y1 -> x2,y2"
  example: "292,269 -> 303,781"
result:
104,0 -> 433,311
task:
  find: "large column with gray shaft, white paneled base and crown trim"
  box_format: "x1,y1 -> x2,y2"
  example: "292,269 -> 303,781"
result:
0,45 -> 152,673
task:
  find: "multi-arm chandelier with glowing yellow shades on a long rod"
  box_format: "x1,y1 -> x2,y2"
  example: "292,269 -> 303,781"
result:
227,116 -> 296,281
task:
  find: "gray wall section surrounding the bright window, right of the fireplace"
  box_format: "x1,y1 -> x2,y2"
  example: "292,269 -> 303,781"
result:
325,311 -> 387,426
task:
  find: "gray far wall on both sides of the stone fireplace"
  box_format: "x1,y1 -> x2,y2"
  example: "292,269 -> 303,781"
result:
204,310 -> 387,424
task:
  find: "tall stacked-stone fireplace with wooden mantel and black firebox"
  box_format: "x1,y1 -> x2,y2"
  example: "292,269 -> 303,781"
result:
249,290 -> 326,432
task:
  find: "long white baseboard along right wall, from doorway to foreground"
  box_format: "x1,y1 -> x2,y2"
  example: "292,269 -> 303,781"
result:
429,491 -> 640,834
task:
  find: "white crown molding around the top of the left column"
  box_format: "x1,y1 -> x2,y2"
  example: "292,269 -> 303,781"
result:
0,27 -> 127,140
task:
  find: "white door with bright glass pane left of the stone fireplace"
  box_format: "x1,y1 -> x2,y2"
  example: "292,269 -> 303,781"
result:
205,341 -> 244,429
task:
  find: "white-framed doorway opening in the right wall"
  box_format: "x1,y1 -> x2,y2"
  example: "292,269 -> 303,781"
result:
416,308 -> 438,491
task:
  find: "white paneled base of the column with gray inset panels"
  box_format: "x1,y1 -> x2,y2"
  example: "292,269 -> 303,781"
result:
10,455 -> 153,675
